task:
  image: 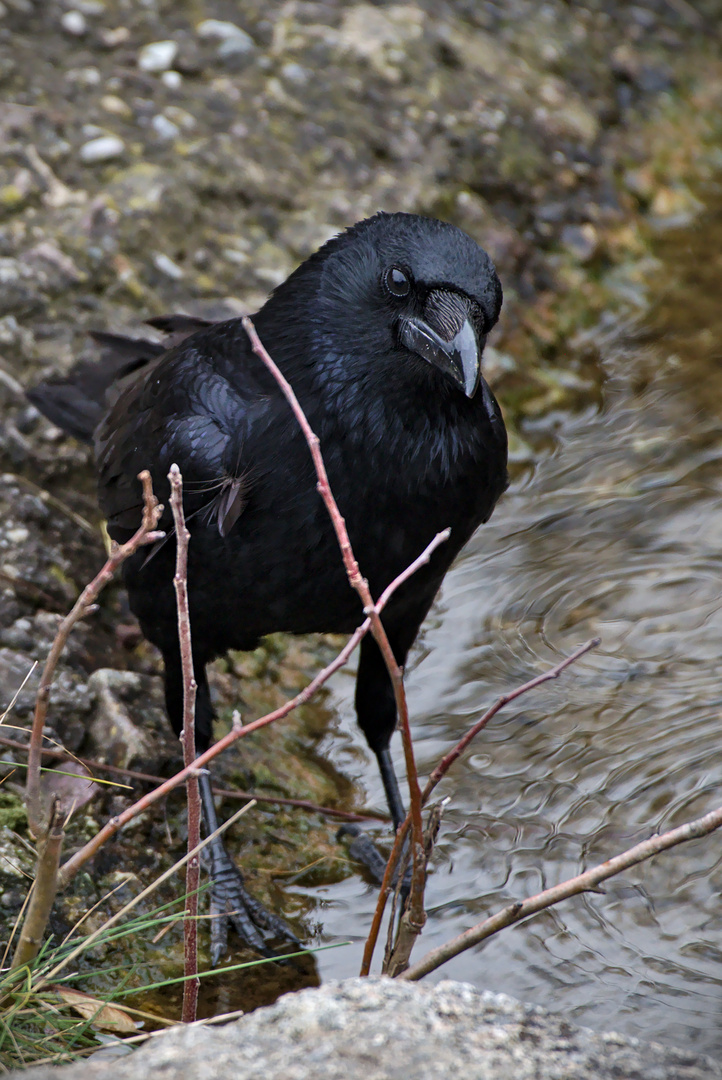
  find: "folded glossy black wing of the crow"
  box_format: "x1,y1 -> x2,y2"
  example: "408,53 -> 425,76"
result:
95,327 -> 278,540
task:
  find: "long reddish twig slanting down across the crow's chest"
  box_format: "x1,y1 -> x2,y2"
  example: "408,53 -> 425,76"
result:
243,316 -> 431,931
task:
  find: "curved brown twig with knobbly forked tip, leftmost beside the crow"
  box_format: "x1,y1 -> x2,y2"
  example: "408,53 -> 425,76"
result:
26,470 -> 164,839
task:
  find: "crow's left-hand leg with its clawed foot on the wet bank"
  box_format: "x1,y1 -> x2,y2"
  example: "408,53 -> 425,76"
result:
165,658 -> 300,967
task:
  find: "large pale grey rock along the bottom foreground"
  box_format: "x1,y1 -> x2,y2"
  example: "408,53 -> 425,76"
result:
13,978 -> 722,1080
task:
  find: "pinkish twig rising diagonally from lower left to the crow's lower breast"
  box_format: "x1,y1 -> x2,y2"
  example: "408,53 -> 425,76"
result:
58,534 -> 446,889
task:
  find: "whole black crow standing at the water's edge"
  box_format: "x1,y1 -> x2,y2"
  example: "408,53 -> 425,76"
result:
29,214 -> 507,958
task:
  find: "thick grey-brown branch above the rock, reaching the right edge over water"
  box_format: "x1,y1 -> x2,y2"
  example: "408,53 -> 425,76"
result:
399,808 -> 722,981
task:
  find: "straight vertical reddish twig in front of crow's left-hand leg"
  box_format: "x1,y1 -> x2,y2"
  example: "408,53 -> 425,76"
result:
168,464 -> 201,1024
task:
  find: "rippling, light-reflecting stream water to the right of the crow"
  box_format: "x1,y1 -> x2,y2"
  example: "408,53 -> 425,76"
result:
302,194 -> 722,1056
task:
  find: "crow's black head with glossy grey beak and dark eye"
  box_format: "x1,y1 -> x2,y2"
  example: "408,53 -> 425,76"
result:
278,214 -> 502,397
